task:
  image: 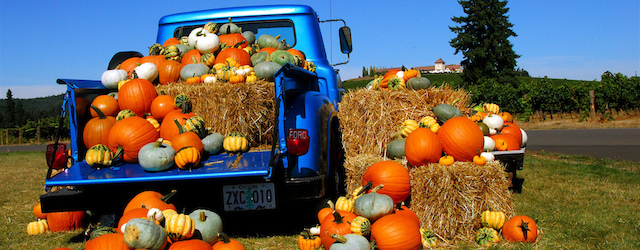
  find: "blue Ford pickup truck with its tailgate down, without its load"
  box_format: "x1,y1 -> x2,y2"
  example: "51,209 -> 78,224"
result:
40,5 -> 351,225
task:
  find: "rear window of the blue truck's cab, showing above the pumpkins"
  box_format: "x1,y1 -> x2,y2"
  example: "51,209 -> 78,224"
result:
173,20 -> 296,47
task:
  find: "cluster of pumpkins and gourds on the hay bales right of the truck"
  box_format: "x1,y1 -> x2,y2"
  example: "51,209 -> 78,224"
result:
387,103 -> 528,166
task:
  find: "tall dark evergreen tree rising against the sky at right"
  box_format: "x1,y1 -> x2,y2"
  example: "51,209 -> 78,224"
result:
449,0 -> 520,85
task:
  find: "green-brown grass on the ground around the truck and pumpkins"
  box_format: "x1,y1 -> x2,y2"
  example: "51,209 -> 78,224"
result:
0,149 -> 640,249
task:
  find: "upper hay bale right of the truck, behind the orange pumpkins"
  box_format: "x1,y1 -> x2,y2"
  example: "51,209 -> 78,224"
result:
338,84 -> 471,156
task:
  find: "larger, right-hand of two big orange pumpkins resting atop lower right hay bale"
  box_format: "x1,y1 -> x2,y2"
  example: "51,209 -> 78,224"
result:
437,116 -> 484,161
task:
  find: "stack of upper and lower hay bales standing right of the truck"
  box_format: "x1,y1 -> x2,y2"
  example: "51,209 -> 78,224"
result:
338,85 -> 515,242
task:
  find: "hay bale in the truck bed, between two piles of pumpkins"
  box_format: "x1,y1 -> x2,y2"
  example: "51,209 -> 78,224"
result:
156,81 -> 275,147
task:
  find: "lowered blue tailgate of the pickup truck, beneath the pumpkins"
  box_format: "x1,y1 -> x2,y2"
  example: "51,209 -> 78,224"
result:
45,150 -> 271,187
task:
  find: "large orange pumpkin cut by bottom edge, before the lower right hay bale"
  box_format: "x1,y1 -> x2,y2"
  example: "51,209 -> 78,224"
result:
371,213 -> 422,250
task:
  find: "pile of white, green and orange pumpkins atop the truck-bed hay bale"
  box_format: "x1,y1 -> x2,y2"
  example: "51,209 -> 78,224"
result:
101,19 -> 315,89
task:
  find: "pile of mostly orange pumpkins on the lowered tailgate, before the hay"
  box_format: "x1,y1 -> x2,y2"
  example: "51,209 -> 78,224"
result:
82,91 -> 249,172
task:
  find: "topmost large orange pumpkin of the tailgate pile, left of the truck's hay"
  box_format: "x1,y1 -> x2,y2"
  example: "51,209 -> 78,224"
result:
118,78 -> 158,116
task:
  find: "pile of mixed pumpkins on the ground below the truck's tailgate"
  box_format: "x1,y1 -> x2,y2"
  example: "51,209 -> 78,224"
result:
27,191 -> 245,250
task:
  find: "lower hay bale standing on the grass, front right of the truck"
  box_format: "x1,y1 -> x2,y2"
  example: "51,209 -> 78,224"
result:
409,161 -> 515,242
